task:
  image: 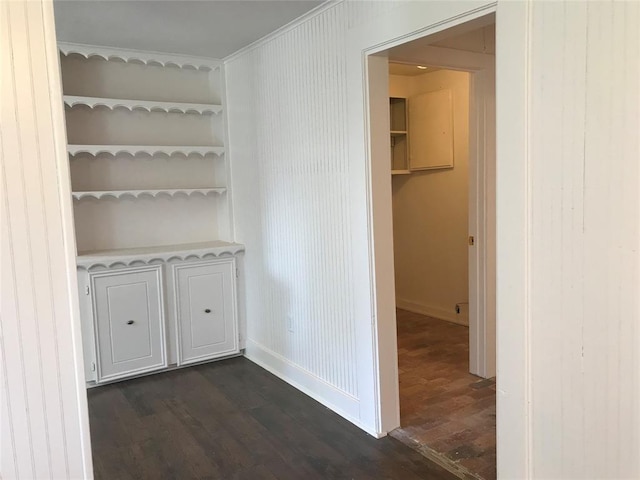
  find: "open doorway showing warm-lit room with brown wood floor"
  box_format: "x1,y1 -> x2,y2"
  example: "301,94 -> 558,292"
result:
369,16 -> 496,478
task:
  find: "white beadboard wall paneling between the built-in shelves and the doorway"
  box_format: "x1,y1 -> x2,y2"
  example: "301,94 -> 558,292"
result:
226,1 -> 357,396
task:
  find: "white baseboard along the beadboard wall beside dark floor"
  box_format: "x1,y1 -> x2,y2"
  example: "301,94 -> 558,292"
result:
244,339 -> 387,438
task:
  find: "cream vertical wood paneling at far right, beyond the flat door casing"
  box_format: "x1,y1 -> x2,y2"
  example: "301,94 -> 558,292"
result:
530,2 -> 640,478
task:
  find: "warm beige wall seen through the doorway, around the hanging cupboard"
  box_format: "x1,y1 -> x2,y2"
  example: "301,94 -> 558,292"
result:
389,70 -> 469,325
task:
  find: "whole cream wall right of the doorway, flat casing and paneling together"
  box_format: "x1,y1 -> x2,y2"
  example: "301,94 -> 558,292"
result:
496,2 -> 640,479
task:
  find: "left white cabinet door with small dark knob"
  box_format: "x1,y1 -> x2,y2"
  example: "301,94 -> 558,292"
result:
91,266 -> 167,382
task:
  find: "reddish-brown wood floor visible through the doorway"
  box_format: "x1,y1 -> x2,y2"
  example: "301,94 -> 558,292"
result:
391,310 -> 496,480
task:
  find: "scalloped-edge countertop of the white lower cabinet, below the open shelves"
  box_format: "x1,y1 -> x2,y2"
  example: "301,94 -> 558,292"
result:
77,240 -> 244,270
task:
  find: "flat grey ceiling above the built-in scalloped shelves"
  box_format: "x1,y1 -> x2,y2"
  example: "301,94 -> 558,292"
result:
54,0 -> 324,59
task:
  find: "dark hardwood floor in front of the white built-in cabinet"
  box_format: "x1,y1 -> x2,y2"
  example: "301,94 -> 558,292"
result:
88,357 -> 456,480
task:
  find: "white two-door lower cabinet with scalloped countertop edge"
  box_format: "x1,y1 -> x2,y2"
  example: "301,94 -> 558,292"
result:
78,248 -> 243,384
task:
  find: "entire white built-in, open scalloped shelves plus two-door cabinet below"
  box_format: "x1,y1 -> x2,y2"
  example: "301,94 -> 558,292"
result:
60,44 -> 243,383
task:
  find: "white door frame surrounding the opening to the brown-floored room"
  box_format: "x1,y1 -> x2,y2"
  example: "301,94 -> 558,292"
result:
358,0 -> 533,478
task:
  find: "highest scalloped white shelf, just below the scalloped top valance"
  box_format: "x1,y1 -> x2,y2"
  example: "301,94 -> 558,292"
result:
64,95 -> 222,114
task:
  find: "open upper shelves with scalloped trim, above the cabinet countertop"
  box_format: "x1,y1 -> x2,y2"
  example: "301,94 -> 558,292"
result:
59,43 -> 233,252
